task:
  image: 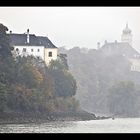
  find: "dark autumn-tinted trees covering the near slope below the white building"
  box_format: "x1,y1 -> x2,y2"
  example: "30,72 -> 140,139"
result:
0,24 -> 78,115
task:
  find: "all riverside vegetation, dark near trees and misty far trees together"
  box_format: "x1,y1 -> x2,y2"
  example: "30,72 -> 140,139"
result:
0,24 -> 137,123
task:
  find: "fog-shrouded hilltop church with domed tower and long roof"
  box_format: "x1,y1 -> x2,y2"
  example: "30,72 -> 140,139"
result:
97,24 -> 140,72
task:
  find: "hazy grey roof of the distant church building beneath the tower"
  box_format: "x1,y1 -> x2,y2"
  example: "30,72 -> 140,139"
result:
99,42 -> 140,58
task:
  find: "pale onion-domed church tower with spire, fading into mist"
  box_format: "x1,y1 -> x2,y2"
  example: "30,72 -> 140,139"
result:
121,23 -> 132,46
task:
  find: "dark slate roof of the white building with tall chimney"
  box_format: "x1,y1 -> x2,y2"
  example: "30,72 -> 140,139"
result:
8,33 -> 57,48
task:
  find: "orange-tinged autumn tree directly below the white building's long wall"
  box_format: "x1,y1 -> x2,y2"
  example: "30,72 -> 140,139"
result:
15,57 -> 43,88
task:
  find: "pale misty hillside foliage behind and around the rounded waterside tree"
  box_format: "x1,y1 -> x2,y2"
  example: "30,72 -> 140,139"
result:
59,47 -> 140,115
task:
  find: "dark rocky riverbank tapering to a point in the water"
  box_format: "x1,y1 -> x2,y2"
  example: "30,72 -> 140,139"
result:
0,111 -> 109,124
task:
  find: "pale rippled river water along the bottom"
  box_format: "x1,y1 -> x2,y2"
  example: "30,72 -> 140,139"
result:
0,118 -> 140,133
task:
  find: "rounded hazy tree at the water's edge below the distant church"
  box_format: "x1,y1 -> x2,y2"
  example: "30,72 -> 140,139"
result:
108,81 -> 138,117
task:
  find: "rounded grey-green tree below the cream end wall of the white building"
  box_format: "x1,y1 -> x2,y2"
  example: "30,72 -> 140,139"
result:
49,60 -> 77,97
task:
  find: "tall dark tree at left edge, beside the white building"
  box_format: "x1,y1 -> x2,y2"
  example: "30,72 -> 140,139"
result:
0,24 -> 14,83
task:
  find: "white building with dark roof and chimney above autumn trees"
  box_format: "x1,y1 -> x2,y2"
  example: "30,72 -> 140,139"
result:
9,29 -> 58,65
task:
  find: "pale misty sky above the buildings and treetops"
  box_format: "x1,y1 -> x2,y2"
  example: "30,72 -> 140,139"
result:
0,7 -> 140,52
